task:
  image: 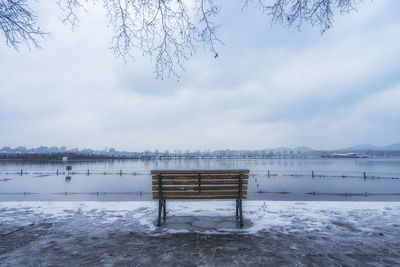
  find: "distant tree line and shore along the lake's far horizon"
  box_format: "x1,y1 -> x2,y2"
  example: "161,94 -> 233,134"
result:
0,146 -> 400,160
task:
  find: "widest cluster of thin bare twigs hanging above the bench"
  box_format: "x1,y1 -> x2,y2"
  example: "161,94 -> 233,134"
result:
104,0 -> 196,79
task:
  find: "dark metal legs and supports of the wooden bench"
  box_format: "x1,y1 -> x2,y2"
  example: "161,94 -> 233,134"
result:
152,170 -> 249,227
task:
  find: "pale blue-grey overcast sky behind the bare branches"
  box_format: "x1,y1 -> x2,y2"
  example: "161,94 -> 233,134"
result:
0,0 -> 400,151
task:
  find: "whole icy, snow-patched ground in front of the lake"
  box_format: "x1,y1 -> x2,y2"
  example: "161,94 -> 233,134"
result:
0,201 -> 400,266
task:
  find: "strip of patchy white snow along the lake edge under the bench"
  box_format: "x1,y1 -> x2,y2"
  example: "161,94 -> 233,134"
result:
0,201 -> 400,234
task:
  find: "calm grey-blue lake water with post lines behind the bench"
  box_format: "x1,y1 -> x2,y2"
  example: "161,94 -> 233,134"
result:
0,158 -> 400,201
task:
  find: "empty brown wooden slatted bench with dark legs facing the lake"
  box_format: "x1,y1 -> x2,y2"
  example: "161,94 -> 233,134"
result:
151,170 -> 249,227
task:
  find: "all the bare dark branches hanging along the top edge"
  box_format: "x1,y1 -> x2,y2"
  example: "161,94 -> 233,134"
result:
0,0 -> 362,79
